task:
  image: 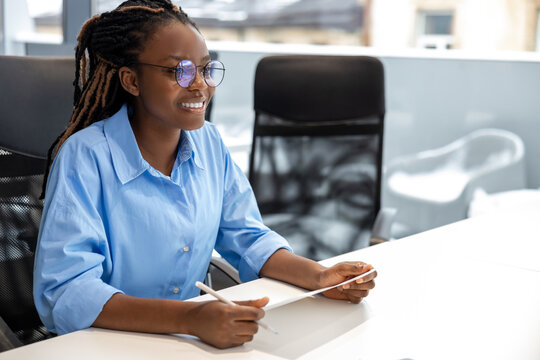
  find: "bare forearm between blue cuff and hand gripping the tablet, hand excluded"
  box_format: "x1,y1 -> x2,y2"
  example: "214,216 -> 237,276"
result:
259,249 -> 326,290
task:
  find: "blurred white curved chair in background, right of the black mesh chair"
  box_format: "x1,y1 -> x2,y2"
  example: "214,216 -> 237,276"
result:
384,129 -> 526,235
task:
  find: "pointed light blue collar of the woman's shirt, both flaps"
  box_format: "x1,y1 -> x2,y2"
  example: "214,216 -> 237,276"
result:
104,105 -> 204,184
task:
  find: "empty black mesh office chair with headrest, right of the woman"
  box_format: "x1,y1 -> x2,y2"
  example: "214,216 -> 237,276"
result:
249,55 -> 389,260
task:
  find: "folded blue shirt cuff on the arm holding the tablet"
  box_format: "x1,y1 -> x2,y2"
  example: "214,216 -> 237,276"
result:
238,231 -> 293,282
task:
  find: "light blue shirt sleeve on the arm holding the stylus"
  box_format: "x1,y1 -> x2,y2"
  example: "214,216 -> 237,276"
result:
34,141 -> 121,334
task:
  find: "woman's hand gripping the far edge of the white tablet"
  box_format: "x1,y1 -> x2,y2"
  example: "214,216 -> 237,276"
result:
320,261 -> 377,304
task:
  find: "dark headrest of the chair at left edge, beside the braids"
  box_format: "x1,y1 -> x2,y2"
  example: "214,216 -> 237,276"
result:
0,56 -> 75,158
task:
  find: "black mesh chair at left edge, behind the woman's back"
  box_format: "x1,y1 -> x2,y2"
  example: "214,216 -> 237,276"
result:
0,56 -> 75,351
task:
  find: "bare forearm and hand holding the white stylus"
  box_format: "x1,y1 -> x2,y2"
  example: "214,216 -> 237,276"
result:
92,293 -> 268,348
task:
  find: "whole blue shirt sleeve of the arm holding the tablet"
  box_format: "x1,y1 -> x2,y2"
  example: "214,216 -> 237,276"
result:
216,145 -> 292,282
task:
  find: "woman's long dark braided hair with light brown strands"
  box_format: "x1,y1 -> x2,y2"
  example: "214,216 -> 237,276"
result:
41,0 -> 198,199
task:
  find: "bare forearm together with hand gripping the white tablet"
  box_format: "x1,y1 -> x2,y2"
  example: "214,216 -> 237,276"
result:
259,249 -> 377,303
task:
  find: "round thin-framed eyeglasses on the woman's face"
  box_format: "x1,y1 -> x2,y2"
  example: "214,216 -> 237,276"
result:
137,60 -> 225,88
